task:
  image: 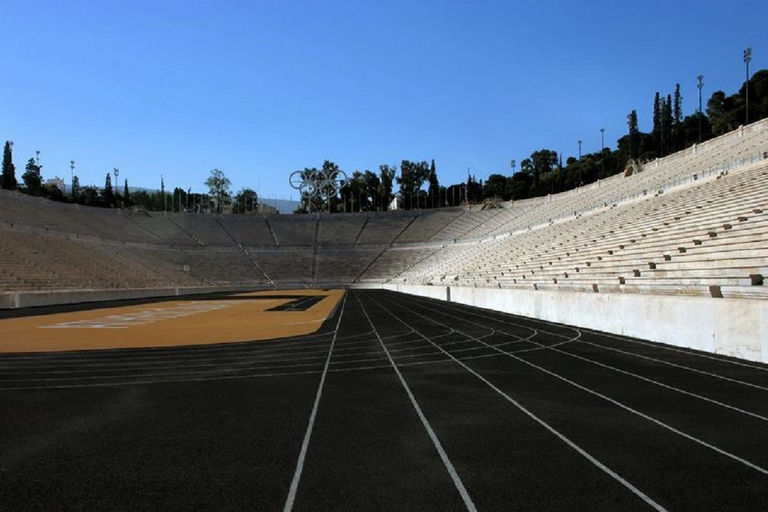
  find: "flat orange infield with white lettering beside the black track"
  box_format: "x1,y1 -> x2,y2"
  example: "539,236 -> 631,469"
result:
0,290 -> 344,352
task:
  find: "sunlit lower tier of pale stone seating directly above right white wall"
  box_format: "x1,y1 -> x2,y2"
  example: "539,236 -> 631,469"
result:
397,160 -> 768,298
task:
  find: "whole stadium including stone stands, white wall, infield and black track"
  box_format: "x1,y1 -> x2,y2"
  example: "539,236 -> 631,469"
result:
0,120 -> 768,510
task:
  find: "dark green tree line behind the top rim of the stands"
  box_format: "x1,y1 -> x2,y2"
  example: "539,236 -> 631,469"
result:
0,70 -> 768,213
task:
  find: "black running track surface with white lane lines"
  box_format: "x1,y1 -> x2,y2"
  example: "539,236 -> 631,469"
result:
0,291 -> 768,511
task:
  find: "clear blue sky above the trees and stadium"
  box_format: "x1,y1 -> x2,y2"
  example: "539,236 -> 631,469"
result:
0,0 -> 768,198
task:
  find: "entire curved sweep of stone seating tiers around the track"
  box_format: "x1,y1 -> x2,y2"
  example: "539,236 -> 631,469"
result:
0,120 -> 768,298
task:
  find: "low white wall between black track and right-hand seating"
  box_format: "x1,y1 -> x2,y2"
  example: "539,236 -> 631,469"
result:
364,284 -> 768,363
